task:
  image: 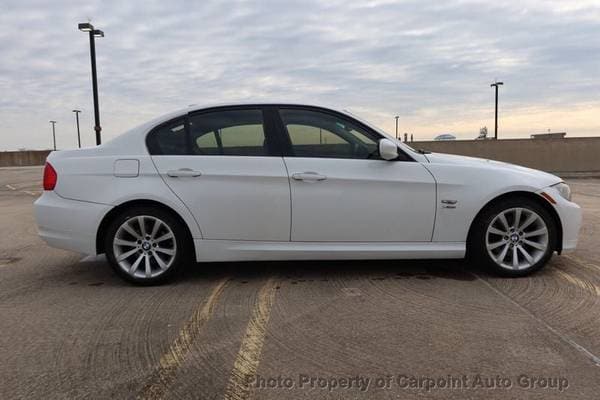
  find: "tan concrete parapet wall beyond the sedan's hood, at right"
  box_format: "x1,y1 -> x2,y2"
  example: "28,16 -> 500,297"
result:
408,137 -> 600,172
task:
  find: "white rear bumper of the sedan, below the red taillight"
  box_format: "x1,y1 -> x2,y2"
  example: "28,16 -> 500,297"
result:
34,191 -> 111,254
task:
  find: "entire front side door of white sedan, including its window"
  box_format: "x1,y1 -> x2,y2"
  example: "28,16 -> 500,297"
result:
279,107 -> 436,242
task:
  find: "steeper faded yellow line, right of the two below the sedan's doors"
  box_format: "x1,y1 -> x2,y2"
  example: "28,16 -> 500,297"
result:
224,278 -> 275,400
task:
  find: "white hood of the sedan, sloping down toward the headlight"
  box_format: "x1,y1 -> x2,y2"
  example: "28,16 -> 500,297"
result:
425,153 -> 562,186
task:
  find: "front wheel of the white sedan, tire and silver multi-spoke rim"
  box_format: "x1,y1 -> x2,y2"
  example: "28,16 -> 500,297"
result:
469,198 -> 557,276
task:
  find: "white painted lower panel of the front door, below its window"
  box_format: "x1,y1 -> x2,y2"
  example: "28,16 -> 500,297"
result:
284,157 -> 435,242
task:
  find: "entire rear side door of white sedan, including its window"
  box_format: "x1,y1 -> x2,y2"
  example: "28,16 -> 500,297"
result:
148,107 -> 290,241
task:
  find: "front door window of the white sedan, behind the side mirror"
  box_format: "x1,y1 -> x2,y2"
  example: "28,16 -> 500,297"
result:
280,109 -> 379,159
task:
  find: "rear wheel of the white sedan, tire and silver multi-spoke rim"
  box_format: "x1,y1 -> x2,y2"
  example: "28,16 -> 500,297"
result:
105,207 -> 188,285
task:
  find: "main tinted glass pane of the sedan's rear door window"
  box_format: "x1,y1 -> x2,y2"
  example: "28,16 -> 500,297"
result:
190,110 -> 269,156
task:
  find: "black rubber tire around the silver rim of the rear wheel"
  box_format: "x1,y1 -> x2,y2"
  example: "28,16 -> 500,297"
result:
104,206 -> 192,286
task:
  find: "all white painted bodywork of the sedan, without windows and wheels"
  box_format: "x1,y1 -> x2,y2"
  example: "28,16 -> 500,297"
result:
35,103 -> 581,261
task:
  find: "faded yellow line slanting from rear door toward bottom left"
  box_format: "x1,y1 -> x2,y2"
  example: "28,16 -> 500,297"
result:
137,278 -> 228,399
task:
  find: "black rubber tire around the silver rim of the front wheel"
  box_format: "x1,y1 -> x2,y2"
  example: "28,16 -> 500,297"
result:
467,196 -> 558,277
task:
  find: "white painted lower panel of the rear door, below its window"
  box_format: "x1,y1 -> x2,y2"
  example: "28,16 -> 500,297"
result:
152,156 -> 290,241
